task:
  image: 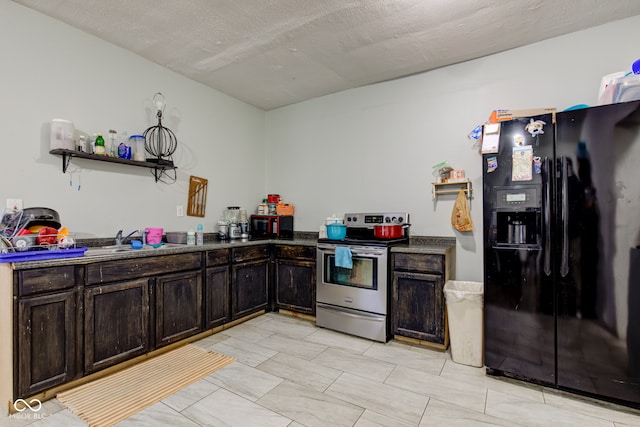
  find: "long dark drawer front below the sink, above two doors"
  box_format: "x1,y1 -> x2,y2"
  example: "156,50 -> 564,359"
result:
87,252 -> 202,284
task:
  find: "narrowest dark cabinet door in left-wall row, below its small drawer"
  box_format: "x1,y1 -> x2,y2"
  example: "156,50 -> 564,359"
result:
204,265 -> 229,329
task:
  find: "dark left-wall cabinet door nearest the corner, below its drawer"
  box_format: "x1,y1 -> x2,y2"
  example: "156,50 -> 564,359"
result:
231,259 -> 269,319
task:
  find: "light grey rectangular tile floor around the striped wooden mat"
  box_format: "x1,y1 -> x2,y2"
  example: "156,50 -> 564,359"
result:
0,313 -> 640,427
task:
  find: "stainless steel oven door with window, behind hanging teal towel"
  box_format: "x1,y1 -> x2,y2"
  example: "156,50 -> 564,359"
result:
316,243 -> 388,314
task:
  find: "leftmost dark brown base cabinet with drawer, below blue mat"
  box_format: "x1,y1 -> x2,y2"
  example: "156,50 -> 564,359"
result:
14,266 -> 82,397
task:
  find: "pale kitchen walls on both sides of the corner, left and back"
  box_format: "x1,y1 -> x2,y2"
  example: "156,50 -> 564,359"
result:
0,0 -> 640,280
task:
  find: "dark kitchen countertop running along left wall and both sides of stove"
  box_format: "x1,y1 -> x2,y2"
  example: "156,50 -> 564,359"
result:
6,233 -> 456,270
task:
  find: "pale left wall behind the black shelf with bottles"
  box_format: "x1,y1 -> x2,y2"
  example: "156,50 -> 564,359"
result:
0,0 -> 265,237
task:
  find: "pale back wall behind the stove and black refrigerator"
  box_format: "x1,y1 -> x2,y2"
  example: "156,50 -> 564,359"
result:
266,17 -> 640,280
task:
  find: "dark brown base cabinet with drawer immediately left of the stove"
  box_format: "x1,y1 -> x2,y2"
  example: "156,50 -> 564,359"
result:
274,245 -> 316,316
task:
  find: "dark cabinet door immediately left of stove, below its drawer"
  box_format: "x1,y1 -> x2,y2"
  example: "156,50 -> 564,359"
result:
275,259 -> 316,315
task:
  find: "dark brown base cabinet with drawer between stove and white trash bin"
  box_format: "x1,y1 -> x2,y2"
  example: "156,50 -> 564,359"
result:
392,253 -> 449,349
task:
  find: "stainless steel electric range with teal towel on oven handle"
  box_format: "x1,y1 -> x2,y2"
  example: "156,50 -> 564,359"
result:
316,212 -> 409,342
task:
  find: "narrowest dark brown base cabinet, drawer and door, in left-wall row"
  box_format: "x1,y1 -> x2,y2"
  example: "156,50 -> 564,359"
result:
204,249 -> 230,329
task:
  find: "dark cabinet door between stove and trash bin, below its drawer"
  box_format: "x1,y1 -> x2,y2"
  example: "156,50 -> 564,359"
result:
393,271 -> 448,347
